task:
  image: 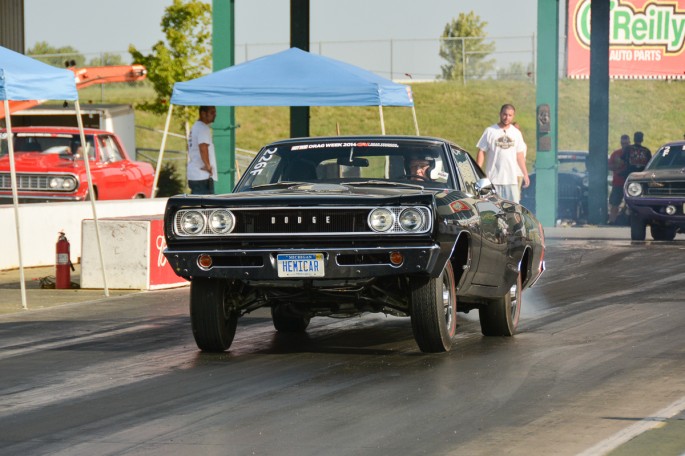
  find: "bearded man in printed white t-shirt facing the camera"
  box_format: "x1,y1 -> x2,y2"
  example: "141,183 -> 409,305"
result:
476,104 -> 530,203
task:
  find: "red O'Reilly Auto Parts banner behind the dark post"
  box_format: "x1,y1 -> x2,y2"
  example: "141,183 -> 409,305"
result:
567,0 -> 685,79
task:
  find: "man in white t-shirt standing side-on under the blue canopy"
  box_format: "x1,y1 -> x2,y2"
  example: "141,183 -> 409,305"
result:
187,106 -> 219,195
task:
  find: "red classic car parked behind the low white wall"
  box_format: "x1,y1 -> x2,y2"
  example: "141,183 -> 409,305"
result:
0,127 -> 155,204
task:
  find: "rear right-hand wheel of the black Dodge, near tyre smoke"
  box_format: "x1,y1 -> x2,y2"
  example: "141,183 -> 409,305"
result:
478,271 -> 523,336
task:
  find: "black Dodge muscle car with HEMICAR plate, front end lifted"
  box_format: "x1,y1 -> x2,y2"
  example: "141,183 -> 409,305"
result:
164,136 -> 545,352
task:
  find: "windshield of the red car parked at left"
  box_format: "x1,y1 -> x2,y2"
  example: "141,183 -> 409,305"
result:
0,132 -> 95,159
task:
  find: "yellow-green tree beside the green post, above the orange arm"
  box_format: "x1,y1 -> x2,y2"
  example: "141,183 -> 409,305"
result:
128,0 -> 212,122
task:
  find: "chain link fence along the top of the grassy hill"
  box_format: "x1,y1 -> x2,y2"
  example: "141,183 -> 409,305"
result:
31,35 -> 535,83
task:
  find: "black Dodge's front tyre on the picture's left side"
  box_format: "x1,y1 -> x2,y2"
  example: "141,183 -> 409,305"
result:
190,278 -> 238,352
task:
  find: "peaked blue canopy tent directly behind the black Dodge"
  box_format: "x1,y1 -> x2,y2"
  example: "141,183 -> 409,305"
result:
154,48 -> 419,192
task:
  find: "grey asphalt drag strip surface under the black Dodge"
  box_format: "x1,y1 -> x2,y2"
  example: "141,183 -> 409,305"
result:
0,240 -> 685,456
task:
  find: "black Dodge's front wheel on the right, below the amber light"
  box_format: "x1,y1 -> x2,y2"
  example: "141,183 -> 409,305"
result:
409,261 -> 457,353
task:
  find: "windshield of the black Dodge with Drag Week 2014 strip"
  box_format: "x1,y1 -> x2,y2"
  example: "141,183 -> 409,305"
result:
235,139 -> 454,192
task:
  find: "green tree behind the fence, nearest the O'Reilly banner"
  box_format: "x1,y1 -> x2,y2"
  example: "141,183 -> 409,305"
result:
440,11 -> 495,80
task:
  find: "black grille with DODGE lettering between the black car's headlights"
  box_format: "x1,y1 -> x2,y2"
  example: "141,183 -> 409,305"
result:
239,208 -> 371,234
